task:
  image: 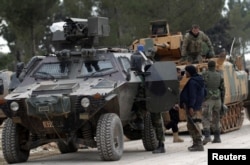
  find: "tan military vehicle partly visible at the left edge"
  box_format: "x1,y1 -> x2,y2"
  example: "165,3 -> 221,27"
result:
0,70 -> 12,125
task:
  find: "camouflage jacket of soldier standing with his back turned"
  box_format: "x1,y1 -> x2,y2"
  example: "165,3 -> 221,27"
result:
202,70 -> 225,102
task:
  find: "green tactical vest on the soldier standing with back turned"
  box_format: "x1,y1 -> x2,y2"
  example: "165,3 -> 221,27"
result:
203,71 -> 221,99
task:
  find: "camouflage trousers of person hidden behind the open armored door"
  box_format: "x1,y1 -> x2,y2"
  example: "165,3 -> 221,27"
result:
150,113 -> 165,142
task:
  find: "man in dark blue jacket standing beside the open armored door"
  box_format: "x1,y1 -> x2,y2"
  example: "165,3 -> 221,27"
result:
180,65 -> 205,151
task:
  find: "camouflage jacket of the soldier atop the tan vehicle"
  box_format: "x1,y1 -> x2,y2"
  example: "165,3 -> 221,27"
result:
181,31 -> 214,56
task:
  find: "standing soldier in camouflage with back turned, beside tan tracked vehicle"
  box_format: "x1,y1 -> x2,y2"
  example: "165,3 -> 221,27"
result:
202,61 -> 225,145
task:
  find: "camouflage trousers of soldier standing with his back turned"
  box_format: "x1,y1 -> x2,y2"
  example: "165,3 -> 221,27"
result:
202,99 -> 221,131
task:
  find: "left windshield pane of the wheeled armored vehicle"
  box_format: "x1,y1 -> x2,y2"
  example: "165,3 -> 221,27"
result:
33,62 -> 69,79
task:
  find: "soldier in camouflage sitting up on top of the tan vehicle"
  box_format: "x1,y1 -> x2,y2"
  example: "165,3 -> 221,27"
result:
181,25 -> 214,63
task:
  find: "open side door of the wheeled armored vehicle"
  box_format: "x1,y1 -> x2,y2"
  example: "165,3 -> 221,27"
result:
145,61 -> 179,113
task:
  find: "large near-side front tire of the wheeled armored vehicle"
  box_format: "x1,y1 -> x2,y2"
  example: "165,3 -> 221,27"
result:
96,113 -> 124,161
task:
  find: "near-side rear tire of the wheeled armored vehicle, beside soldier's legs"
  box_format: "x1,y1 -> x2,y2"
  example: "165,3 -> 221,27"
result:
142,112 -> 158,151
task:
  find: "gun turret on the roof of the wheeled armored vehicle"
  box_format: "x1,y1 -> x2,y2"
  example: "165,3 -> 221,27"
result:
51,17 -> 110,50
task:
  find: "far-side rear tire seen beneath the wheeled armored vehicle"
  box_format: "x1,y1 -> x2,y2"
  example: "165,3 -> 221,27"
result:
57,138 -> 78,154
